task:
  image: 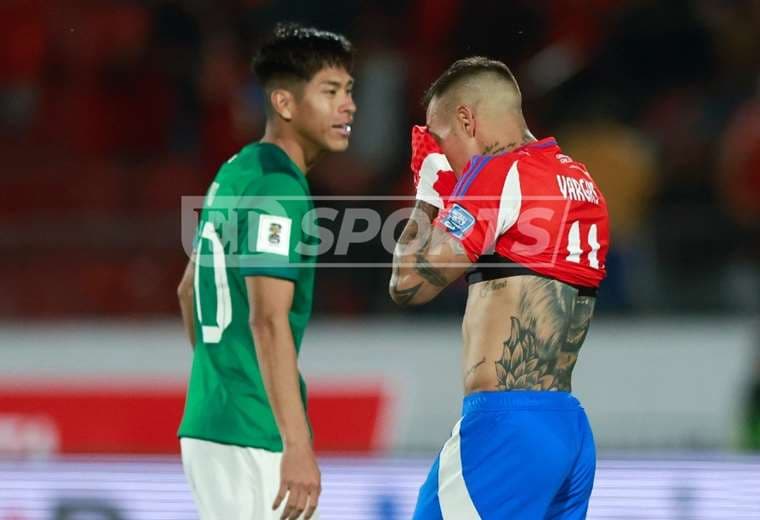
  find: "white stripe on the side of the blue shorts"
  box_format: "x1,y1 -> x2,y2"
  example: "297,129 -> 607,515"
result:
438,419 -> 480,520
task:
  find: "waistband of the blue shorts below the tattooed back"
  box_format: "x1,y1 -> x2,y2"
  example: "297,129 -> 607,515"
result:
462,390 -> 581,415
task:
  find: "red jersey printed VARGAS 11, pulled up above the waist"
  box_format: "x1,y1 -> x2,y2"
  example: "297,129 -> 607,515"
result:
436,138 -> 609,288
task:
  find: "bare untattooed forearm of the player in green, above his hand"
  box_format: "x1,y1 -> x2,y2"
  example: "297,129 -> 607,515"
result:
251,315 -> 311,446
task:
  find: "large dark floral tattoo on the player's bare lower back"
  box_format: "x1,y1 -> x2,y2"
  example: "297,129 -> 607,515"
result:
494,277 -> 595,392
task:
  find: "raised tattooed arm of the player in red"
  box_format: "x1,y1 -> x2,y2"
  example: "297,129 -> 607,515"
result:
389,201 -> 470,306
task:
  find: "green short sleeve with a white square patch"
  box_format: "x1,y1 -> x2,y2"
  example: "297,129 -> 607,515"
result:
237,173 -> 311,281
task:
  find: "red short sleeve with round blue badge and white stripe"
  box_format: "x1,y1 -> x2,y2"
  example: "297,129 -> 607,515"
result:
434,156 -> 521,262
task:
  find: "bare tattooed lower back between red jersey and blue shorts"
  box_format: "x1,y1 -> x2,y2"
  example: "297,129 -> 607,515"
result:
462,275 -> 596,394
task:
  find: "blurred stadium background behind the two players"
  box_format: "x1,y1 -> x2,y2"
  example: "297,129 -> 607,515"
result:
0,0 -> 760,520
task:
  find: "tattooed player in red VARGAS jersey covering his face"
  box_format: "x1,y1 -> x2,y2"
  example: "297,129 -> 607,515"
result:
390,57 -> 609,520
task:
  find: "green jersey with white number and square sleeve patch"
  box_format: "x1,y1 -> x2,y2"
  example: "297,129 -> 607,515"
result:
179,143 -> 318,451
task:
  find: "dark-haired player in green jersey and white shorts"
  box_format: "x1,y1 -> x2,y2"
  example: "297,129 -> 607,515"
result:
178,24 -> 356,520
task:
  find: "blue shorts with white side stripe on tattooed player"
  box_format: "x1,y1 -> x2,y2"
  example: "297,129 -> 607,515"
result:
414,391 -> 596,520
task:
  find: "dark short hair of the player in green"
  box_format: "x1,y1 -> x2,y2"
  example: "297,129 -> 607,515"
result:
253,23 -> 354,88
